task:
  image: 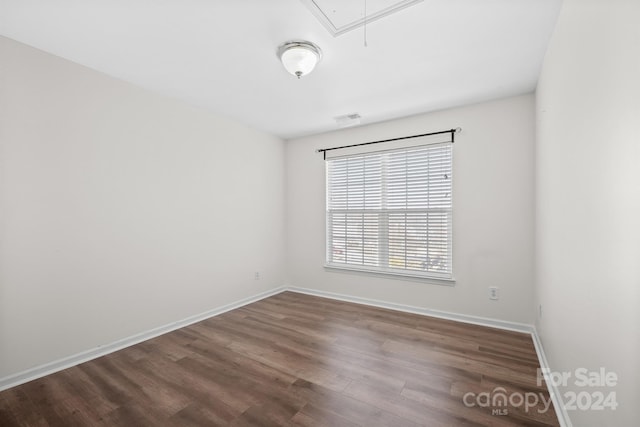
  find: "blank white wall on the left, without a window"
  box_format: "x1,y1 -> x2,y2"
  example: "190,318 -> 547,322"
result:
0,38 -> 284,378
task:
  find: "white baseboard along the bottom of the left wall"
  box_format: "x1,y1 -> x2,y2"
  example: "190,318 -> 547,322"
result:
0,287 -> 286,391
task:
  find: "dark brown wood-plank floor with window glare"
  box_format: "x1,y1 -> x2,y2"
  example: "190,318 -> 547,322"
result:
0,292 -> 558,427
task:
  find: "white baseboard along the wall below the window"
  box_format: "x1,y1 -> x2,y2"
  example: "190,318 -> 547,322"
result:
286,286 -> 534,334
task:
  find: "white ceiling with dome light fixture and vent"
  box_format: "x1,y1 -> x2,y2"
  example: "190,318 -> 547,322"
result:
0,0 -> 561,138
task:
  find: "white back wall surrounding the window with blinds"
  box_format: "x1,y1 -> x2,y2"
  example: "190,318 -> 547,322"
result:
286,95 -> 535,323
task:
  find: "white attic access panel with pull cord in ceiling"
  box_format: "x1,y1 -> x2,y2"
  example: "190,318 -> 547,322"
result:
301,0 -> 422,37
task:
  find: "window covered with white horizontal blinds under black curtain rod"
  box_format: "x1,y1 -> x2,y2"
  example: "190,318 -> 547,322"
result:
327,143 -> 453,280
